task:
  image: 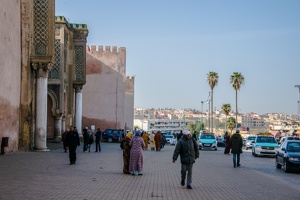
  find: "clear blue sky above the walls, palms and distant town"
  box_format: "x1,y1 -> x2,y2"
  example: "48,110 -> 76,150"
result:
55,0 -> 300,114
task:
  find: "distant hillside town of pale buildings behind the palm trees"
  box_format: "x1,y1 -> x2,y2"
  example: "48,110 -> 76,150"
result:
134,108 -> 300,137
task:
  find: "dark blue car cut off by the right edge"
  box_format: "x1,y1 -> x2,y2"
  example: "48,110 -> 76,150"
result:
276,140 -> 300,172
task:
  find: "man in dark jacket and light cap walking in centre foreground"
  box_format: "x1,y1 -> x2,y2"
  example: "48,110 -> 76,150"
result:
173,130 -> 199,189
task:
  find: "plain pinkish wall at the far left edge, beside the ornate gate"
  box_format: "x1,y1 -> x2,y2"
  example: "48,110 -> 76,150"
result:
0,0 -> 21,152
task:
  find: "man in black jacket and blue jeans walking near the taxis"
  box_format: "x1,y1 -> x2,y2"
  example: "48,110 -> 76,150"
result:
230,130 -> 243,168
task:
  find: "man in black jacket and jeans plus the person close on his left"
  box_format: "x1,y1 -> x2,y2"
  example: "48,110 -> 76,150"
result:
224,130 -> 243,168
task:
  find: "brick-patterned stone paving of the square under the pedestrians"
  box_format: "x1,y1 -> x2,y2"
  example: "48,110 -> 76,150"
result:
0,143 -> 300,200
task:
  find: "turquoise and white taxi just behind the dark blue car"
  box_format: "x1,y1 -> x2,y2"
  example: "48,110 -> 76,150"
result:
252,133 -> 279,157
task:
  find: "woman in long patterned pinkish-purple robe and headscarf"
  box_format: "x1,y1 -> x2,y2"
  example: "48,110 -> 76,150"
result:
129,131 -> 145,175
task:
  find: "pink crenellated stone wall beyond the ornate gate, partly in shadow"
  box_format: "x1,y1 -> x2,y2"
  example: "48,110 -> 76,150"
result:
82,46 -> 126,130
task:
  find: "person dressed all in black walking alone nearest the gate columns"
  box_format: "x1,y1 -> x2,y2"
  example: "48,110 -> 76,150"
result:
66,126 -> 80,165
